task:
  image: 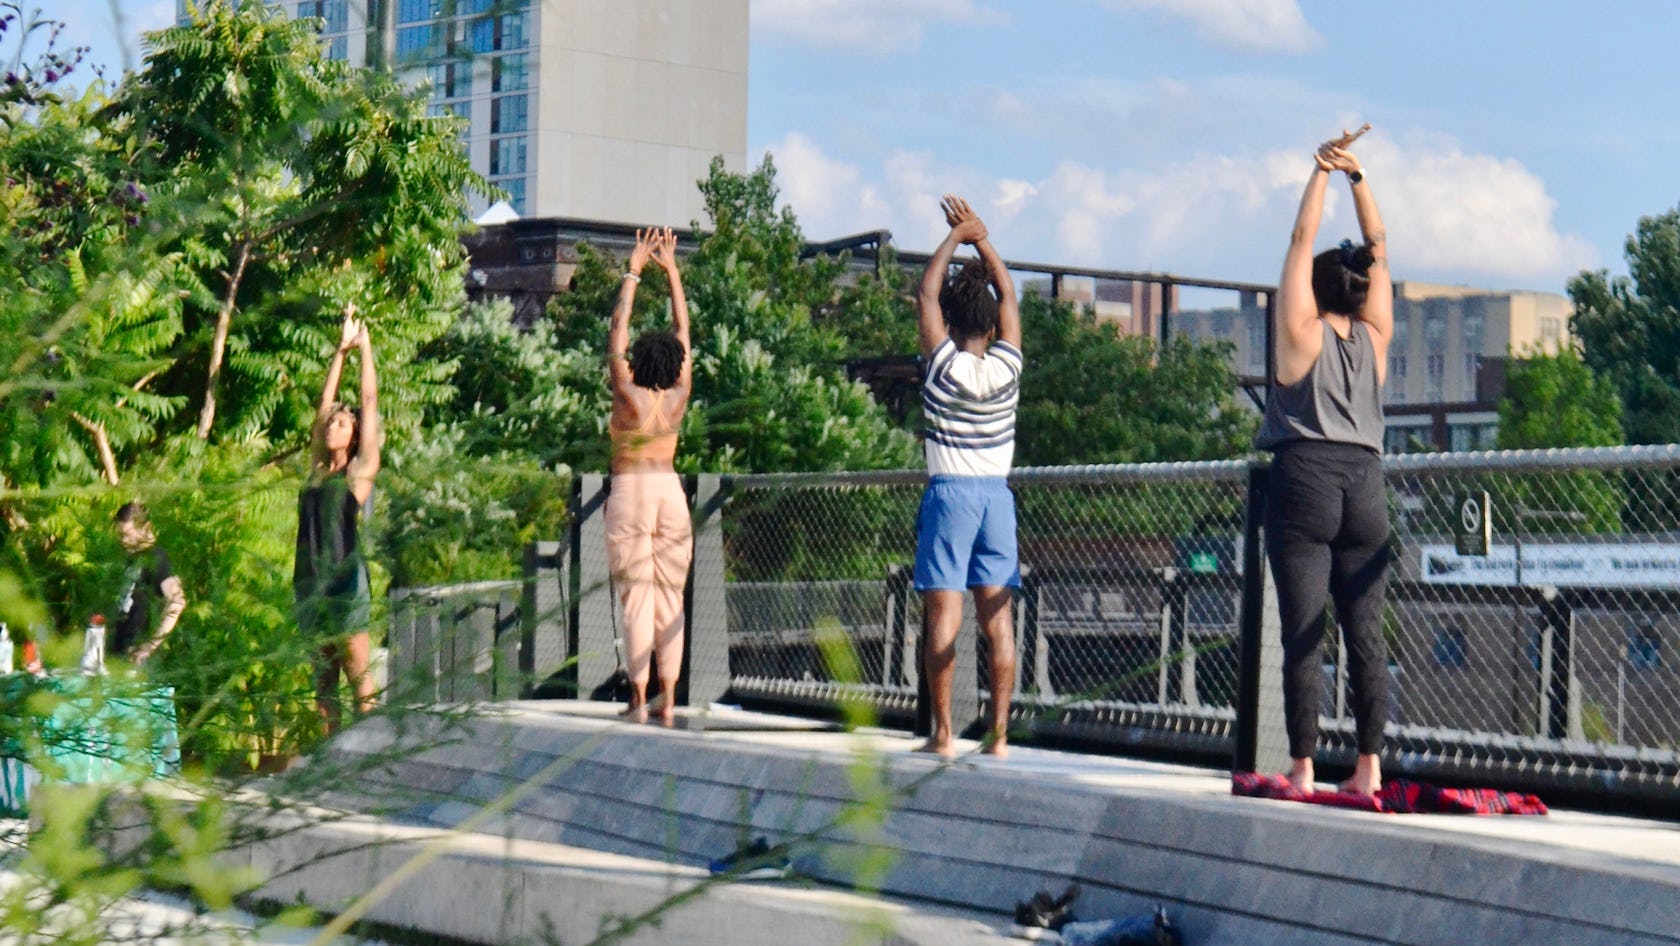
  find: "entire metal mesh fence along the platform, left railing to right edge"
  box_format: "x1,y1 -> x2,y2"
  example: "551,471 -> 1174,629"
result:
391,447 -> 1680,796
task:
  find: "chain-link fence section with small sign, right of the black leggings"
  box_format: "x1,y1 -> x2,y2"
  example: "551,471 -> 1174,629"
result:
1377,447 -> 1680,793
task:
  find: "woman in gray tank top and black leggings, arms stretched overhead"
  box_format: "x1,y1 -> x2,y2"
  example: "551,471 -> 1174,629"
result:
1255,126 -> 1394,795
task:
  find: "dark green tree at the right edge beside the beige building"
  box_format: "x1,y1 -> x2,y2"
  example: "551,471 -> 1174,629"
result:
1569,208 -> 1680,444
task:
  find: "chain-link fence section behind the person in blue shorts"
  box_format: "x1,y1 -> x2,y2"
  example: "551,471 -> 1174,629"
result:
722,464 -> 1248,754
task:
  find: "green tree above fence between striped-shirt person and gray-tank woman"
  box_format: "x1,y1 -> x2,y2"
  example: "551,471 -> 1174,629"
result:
1015,296 -> 1255,465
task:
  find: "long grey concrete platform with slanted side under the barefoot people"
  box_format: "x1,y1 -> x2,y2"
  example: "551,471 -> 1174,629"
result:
288,702 -> 1680,946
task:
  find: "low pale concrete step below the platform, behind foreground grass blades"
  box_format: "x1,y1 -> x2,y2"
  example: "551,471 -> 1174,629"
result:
232,817 -> 1008,946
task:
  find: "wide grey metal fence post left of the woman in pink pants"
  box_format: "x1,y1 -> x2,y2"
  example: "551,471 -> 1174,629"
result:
571,474 -> 618,699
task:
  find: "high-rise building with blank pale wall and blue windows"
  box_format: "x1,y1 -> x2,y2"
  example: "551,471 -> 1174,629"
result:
176,0 -> 748,225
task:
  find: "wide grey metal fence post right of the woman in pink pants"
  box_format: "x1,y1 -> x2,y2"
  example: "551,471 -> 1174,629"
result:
682,474 -> 729,706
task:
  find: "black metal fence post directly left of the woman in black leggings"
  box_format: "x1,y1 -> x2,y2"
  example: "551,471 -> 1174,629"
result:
1231,464 -> 1289,771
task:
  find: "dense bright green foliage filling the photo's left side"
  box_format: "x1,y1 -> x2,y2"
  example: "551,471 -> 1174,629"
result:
0,0 -> 490,768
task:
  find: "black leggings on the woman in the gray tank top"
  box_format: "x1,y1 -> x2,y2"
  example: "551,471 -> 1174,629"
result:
1265,440 -> 1388,759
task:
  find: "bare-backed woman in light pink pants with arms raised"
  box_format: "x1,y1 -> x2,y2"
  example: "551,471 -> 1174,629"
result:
606,227 -> 694,726
